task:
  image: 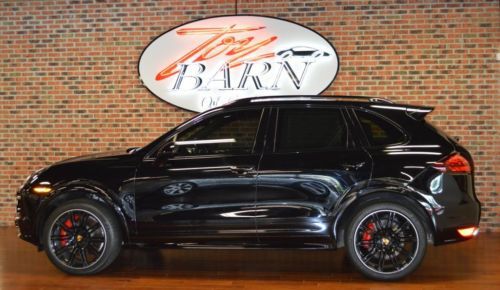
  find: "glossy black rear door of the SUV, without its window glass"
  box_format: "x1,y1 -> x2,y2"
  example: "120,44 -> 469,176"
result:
256,104 -> 371,247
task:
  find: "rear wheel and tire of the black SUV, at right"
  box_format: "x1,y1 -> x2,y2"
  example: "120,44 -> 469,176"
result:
345,202 -> 427,281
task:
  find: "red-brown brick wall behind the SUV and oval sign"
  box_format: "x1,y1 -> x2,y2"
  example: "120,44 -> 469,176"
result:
0,0 -> 500,231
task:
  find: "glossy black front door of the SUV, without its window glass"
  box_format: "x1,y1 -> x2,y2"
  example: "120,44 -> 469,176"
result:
135,109 -> 269,243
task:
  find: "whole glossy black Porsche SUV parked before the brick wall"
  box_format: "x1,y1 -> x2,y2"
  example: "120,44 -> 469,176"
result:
16,97 -> 480,280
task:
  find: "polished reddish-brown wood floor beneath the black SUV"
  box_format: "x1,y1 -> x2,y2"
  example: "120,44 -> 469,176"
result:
0,227 -> 500,290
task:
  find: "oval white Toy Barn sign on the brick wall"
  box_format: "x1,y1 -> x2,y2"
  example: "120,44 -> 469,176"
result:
139,15 -> 339,112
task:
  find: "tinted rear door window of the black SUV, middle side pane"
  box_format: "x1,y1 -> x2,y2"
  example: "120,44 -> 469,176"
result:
276,108 -> 347,152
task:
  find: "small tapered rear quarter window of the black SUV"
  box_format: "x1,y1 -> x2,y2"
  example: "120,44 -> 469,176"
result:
356,110 -> 405,146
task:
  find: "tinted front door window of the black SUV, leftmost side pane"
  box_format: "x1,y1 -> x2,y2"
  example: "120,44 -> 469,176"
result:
176,110 -> 261,156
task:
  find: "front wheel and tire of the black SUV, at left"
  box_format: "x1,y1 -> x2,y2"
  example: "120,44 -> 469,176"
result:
43,199 -> 123,275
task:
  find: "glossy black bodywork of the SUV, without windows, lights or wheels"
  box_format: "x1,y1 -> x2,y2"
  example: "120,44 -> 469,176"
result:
16,97 -> 480,248
